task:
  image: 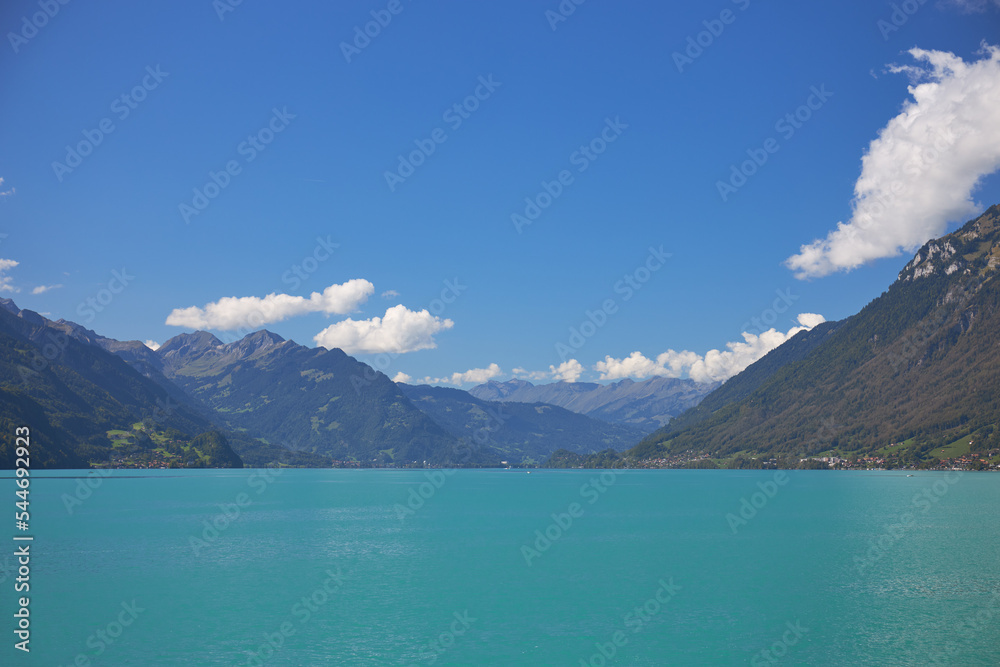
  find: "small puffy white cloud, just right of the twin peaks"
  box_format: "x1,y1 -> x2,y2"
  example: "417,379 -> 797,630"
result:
313,305 -> 455,354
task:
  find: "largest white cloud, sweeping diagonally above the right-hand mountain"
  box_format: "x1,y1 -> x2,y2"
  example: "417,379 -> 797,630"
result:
785,45 -> 1000,278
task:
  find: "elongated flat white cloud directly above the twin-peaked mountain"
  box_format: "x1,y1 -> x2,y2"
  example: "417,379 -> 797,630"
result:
167,278 -> 375,331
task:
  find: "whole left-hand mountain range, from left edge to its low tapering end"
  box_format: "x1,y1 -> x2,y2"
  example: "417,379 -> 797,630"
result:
0,299 -> 676,467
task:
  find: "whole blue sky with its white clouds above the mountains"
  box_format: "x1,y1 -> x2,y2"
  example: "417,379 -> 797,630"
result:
0,0 -> 1000,388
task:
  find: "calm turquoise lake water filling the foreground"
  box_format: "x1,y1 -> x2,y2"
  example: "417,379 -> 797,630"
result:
7,470 -> 1000,666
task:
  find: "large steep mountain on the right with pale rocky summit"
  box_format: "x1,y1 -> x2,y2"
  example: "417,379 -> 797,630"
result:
627,206 -> 1000,463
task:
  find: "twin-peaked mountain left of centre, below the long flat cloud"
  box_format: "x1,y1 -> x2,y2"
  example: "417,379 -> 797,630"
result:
149,330 -> 474,463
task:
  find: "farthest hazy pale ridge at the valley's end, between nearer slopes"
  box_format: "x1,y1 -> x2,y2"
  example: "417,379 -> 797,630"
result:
469,377 -> 718,433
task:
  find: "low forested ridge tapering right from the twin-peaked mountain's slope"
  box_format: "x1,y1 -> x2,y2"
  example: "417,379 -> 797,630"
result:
399,384 -> 643,462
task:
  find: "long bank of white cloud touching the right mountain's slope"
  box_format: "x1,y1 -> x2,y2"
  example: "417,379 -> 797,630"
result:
594,313 -> 826,382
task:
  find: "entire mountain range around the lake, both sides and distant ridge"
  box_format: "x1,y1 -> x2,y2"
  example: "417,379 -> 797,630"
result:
7,206 -> 1000,468
